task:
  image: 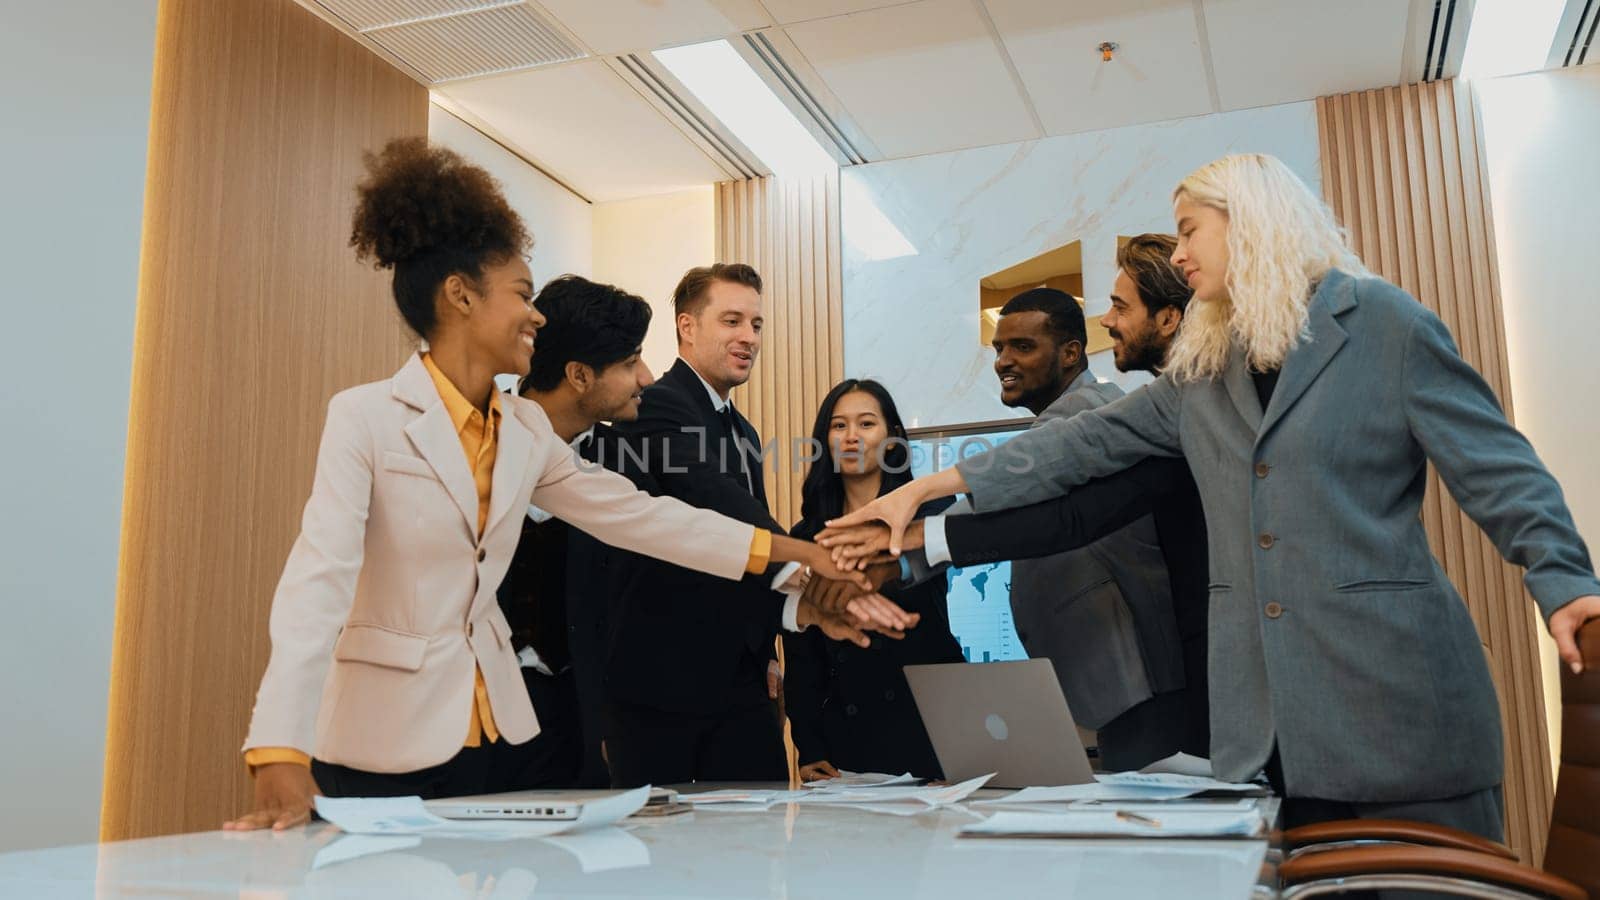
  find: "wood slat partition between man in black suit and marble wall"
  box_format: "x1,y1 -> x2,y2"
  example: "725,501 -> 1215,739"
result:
717,175 -> 845,527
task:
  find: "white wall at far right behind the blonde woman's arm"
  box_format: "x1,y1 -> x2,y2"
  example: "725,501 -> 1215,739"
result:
1474,66 -> 1600,771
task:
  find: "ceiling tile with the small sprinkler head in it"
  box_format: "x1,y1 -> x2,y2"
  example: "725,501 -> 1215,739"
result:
986,0 -> 1211,135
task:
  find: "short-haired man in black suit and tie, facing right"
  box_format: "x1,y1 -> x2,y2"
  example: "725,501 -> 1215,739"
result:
603,264 -> 851,786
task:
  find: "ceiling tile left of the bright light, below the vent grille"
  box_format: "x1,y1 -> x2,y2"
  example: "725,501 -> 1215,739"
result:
435,59 -> 728,202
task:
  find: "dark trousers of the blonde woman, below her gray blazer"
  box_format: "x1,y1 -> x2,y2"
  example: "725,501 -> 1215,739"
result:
1267,748 -> 1506,900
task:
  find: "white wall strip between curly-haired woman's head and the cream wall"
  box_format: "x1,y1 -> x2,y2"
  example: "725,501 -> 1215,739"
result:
427,106 -> 594,285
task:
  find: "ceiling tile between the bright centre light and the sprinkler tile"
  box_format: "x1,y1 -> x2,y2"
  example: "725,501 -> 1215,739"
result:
784,0 -> 1042,157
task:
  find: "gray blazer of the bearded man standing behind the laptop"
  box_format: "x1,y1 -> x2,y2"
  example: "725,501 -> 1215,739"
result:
1011,370 -> 1184,729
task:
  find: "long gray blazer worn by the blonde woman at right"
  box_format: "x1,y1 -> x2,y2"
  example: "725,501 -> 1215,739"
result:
958,271 -> 1600,802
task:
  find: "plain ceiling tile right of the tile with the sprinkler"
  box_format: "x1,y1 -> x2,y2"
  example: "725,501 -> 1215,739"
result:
1203,0 -> 1411,109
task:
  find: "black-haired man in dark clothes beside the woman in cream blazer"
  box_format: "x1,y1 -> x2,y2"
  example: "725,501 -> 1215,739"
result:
499,275 -> 654,790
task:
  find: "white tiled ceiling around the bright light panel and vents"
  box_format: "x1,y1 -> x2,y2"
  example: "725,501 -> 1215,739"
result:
299,0 -> 1466,200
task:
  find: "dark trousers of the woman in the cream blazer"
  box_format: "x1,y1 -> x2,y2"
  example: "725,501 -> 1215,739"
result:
310,669 -> 582,799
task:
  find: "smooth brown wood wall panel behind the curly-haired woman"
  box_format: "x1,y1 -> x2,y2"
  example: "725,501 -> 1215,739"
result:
101,0 -> 427,839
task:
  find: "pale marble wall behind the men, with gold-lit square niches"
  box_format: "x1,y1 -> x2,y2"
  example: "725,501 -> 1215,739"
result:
840,102 -> 1320,428
